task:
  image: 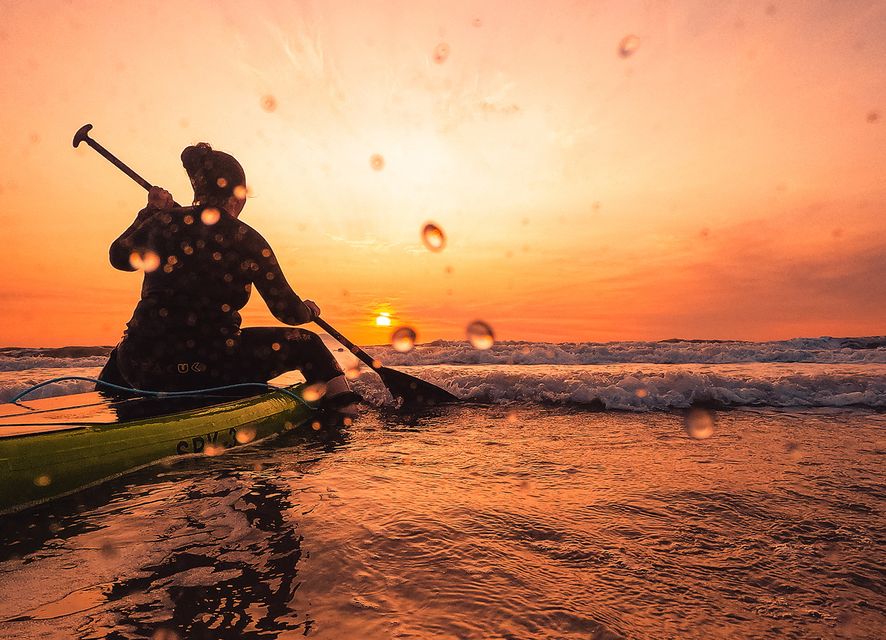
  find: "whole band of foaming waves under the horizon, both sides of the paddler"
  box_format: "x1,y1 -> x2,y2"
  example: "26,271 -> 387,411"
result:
0,338 -> 886,411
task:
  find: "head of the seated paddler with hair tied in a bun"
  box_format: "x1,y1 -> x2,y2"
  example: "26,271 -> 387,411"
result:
182,142 -> 246,218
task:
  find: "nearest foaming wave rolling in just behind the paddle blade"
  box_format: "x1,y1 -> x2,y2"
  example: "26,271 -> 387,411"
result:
350,363 -> 886,411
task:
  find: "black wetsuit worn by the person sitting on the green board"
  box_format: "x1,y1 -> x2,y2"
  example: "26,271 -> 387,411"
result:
102,207 -> 341,391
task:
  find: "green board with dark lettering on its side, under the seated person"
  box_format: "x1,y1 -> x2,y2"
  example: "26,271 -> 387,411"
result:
0,385 -> 314,514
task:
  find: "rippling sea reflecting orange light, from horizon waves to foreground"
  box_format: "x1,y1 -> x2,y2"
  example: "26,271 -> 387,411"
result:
0,337 -> 886,640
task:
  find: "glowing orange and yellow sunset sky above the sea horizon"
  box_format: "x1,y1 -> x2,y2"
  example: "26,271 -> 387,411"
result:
0,0 -> 886,346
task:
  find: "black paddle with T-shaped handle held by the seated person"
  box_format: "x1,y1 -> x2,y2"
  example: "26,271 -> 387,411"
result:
73,124 -> 458,406
